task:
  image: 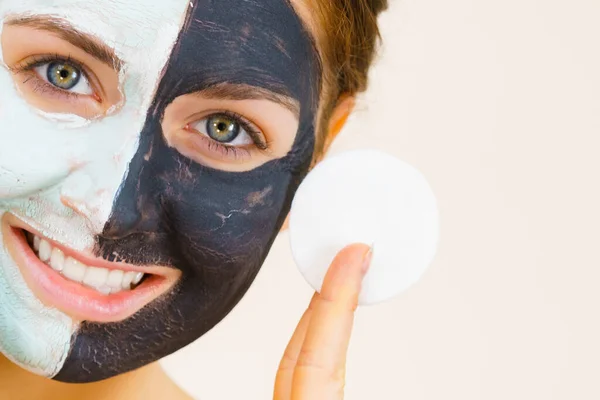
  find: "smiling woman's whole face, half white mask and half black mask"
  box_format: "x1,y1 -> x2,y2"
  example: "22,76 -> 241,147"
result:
0,0 -> 321,382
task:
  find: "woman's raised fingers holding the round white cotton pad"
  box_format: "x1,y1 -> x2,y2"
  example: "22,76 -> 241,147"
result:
274,244 -> 371,400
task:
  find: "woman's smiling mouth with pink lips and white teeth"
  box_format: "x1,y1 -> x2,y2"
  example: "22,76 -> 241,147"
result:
2,214 -> 181,322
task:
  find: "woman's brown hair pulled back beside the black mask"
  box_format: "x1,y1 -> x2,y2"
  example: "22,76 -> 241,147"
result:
310,0 -> 388,156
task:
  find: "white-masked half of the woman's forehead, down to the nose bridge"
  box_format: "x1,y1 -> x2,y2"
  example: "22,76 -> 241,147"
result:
0,0 -> 190,109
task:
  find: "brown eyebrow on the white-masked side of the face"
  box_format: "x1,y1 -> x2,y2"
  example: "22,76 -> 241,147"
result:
6,15 -> 123,70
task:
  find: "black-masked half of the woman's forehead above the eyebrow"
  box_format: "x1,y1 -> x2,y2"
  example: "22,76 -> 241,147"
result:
156,0 -> 319,105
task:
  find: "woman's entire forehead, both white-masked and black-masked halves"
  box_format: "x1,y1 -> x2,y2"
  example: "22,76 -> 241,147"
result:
0,0 -> 321,111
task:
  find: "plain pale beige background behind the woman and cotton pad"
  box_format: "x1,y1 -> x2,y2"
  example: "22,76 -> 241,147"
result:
165,0 -> 600,400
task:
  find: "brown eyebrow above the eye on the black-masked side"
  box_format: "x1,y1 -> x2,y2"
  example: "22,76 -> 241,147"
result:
196,83 -> 300,118
